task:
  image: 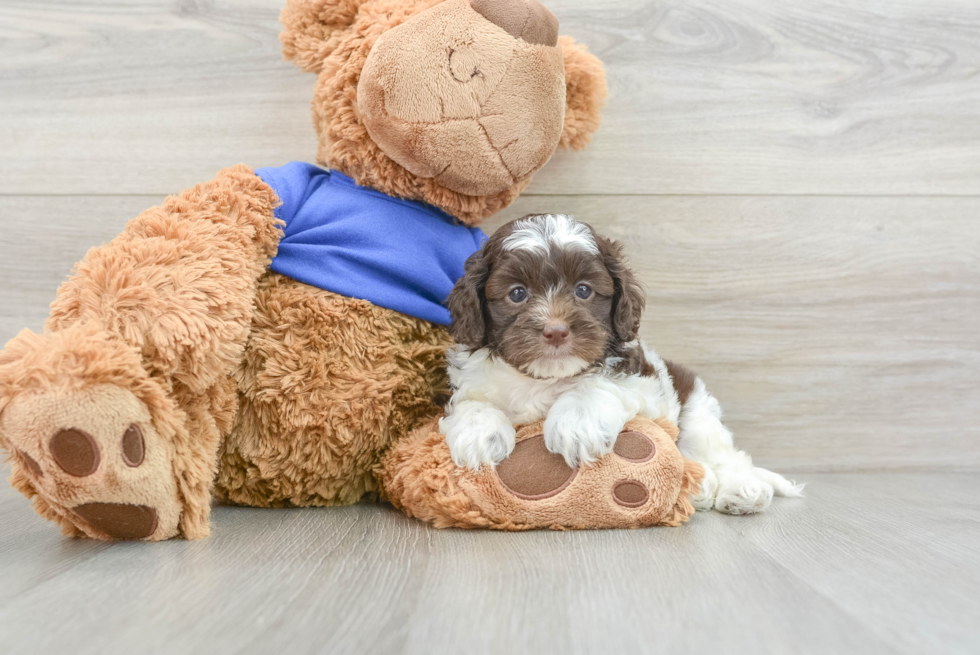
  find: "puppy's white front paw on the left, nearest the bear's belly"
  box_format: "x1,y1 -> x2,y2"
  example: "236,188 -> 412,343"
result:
439,402 -> 517,471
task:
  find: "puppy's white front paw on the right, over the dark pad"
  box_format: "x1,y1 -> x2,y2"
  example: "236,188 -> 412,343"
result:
544,398 -> 626,468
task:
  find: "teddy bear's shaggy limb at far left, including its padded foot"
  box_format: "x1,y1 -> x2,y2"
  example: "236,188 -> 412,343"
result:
0,166 -> 280,540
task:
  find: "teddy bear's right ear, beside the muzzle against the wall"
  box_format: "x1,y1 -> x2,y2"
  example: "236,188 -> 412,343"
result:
558,36 -> 608,150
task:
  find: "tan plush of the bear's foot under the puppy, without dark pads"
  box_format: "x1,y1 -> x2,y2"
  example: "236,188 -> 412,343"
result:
381,418 -> 703,530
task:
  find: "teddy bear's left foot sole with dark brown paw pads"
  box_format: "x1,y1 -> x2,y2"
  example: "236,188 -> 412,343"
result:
0,326 -> 182,541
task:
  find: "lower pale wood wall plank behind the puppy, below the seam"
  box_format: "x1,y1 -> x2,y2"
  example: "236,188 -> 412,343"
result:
0,196 -> 980,472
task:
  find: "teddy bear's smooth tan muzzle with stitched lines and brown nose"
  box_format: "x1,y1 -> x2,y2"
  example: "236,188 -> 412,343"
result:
357,0 -> 565,196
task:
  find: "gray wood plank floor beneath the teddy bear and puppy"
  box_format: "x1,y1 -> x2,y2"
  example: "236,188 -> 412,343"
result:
0,473 -> 980,655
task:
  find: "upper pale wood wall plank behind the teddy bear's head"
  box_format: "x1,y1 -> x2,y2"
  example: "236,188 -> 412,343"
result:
0,0 -> 980,195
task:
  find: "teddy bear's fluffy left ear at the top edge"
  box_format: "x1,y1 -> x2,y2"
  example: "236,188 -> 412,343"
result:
279,0 -> 365,73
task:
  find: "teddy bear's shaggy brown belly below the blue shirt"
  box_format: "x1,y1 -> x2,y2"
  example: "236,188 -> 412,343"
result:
215,273 -> 450,507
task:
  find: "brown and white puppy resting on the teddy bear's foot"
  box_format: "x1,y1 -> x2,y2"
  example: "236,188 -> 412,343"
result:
440,214 -> 802,514
